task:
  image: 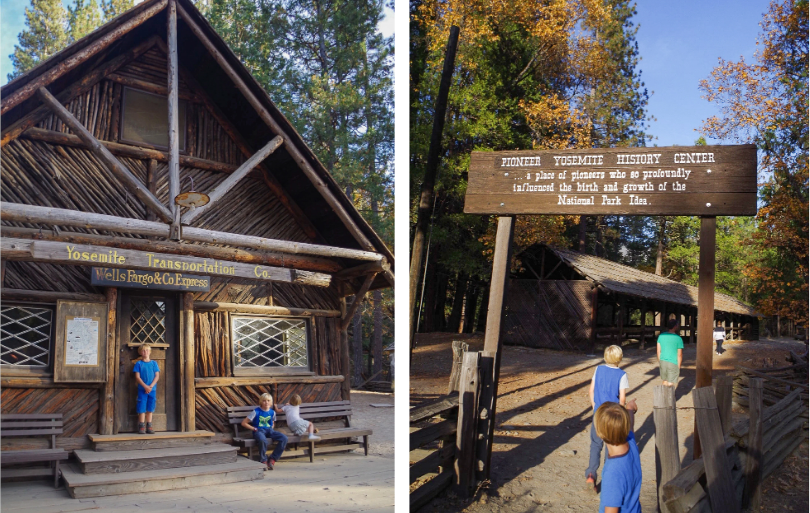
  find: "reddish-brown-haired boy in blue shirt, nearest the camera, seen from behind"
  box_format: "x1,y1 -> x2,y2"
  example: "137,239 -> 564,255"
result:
594,399 -> 641,513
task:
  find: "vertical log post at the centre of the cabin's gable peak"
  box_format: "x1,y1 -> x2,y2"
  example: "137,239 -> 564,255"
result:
166,0 -> 180,240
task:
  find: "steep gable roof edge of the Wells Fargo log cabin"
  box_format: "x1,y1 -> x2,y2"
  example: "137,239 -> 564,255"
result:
0,0 -> 394,288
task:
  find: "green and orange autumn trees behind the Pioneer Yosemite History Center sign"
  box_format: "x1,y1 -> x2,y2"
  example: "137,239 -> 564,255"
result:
410,0 -> 808,332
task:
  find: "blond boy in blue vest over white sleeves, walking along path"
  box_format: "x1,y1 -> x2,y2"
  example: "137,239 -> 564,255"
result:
585,346 -> 630,492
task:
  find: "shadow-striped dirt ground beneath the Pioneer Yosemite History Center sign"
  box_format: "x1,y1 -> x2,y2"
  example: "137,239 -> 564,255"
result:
410,333 -> 808,513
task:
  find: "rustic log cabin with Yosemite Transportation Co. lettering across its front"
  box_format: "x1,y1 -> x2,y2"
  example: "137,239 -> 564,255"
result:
0,0 -> 393,450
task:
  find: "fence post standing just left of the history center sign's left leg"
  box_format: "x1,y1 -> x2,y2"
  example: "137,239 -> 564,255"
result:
455,352 -> 478,498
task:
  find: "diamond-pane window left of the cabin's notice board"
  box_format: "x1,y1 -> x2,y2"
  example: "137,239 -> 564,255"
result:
0,306 -> 53,369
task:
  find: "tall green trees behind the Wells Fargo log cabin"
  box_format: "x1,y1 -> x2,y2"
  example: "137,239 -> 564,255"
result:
3,0 -> 394,384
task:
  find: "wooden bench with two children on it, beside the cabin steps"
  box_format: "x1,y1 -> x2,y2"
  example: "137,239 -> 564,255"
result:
227,401 -> 372,462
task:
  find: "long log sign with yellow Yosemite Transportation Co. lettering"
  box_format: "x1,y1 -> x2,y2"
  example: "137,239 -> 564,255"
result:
0,237 -> 332,287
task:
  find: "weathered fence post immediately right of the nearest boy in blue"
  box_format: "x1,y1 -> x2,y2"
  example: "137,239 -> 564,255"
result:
653,385 -> 681,512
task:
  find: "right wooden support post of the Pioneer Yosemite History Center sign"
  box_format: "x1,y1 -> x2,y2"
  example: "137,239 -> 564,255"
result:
692,216 -> 717,459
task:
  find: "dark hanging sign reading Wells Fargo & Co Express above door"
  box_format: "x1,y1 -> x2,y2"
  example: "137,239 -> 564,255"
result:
90,267 -> 211,292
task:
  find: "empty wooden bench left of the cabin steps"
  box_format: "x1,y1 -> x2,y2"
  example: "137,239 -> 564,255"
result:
0,413 -> 69,488
